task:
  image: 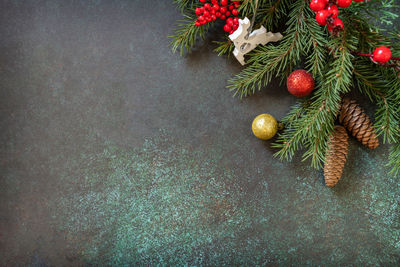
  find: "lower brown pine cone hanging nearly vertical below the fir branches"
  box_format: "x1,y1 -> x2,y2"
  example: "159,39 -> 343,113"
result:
324,125 -> 349,187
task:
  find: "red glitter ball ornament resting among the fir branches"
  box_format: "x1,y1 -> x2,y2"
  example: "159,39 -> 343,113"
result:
286,70 -> 315,97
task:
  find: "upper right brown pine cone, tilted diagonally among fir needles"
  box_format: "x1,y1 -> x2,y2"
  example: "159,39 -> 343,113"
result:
339,98 -> 379,149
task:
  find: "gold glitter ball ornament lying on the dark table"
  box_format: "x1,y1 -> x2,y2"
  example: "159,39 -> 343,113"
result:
251,113 -> 278,140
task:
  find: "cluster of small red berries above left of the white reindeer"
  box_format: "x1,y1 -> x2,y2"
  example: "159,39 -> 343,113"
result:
194,0 -> 240,34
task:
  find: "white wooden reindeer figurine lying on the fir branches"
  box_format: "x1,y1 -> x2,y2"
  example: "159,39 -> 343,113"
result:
229,18 -> 283,65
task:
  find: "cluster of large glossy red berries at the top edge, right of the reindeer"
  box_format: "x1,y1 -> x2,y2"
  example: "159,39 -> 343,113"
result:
310,0 -> 364,35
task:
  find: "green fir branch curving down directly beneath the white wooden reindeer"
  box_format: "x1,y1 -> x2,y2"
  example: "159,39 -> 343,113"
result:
228,0 -> 309,97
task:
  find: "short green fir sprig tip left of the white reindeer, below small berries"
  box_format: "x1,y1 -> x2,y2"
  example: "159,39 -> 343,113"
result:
169,15 -> 213,55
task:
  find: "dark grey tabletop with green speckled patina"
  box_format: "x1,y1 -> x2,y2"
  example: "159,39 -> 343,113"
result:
0,0 -> 400,266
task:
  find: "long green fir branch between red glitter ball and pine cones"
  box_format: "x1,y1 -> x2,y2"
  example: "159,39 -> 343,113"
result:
273,32 -> 354,168
